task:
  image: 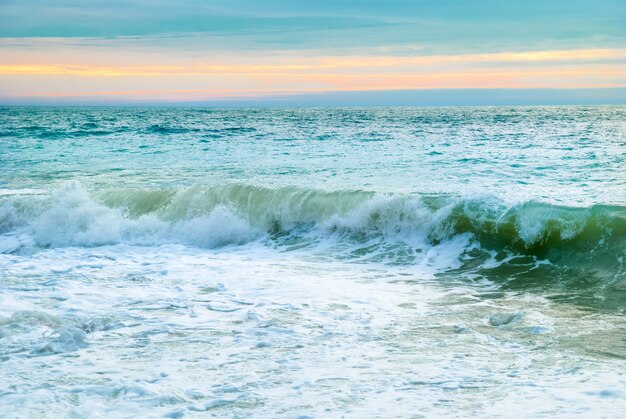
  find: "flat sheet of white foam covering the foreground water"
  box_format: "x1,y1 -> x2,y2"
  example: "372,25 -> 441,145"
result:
0,244 -> 626,417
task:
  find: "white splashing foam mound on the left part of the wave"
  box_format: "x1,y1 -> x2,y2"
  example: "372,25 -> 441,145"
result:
11,182 -> 258,250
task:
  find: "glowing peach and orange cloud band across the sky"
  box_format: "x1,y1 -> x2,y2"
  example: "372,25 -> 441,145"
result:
0,49 -> 626,99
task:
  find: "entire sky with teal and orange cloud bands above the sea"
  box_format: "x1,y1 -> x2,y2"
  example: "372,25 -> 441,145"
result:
0,0 -> 626,105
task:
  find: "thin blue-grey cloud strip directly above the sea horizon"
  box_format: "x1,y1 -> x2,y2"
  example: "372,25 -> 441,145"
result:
0,86 -> 626,108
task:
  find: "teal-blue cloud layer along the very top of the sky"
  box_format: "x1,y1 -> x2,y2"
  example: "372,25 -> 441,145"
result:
0,0 -> 626,53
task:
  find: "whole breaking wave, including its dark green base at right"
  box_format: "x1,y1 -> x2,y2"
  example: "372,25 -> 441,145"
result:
0,182 -> 626,305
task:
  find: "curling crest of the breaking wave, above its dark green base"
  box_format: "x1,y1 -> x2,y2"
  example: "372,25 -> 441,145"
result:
0,182 -> 626,256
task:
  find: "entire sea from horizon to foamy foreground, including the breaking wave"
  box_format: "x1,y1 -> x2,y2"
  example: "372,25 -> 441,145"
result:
0,106 -> 626,418
